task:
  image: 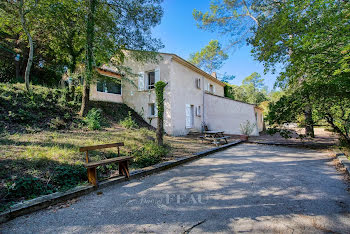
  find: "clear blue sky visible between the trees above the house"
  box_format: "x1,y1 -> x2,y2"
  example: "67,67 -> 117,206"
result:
153,0 -> 277,90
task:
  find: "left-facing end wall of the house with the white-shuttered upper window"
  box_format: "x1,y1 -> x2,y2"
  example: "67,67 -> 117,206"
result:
122,55 -> 173,134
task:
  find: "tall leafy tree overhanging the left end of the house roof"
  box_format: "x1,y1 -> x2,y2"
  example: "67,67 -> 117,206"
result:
80,0 -> 163,115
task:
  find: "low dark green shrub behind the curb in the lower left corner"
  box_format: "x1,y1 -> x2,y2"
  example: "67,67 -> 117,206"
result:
6,177 -> 52,198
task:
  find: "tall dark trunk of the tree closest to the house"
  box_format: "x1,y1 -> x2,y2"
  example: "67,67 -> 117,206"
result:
79,0 -> 97,116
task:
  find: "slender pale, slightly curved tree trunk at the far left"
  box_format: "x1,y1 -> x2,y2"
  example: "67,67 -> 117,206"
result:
19,0 -> 34,92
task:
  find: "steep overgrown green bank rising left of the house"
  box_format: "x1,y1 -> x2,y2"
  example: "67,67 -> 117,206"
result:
0,83 -> 152,133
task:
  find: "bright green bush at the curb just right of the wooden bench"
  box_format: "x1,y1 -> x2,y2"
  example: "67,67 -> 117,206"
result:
133,142 -> 168,167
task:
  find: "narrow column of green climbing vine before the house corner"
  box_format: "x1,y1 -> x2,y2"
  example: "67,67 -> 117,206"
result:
155,81 -> 167,145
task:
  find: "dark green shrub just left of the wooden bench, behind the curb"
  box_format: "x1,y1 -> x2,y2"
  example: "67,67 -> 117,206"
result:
52,165 -> 87,190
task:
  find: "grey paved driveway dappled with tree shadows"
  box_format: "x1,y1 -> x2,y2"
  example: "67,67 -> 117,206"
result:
0,144 -> 350,233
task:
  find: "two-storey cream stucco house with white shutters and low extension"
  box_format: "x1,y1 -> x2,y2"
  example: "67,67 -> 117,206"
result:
90,53 -> 263,136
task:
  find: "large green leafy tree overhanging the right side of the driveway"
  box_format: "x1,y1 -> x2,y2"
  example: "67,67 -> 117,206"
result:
260,0 -> 350,142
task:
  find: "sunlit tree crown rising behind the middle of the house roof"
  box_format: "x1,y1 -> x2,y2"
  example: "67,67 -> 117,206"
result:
189,40 -> 228,73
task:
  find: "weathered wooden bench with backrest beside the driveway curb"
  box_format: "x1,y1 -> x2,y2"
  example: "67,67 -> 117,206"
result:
79,142 -> 133,186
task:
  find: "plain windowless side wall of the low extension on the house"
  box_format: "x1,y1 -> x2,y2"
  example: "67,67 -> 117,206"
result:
204,93 -> 259,136
